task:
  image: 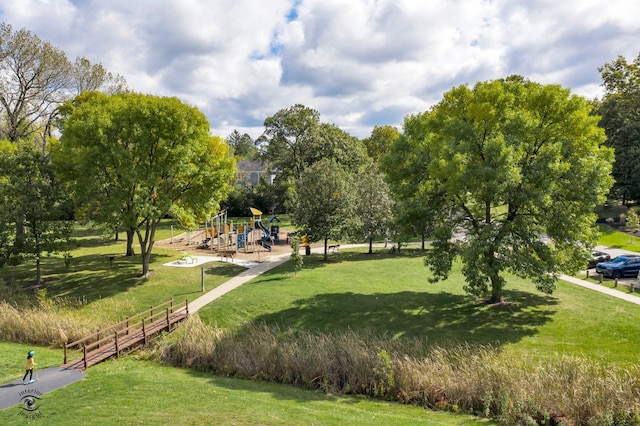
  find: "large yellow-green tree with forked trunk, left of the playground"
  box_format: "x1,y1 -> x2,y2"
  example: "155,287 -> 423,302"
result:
52,92 -> 235,276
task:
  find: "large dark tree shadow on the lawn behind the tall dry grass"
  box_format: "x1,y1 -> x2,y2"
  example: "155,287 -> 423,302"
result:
249,290 -> 557,346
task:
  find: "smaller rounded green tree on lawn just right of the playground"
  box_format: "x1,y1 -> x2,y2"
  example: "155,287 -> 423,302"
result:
292,159 -> 360,260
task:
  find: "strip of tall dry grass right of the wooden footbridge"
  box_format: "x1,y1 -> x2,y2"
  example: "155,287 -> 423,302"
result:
157,316 -> 640,425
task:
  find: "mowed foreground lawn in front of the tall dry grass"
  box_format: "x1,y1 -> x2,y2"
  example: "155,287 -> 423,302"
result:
0,343 -> 493,425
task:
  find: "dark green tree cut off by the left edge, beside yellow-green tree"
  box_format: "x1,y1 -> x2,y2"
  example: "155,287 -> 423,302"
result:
0,141 -> 72,284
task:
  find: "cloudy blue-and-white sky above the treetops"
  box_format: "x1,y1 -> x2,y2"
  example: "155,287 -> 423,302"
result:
0,0 -> 640,138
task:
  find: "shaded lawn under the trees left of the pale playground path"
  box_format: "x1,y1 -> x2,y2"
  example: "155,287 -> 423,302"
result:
0,224 -> 245,322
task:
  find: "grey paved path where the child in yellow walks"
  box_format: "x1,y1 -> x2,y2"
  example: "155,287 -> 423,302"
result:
0,367 -> 85,410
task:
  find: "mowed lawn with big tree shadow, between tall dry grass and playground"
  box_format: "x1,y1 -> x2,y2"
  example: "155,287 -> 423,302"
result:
198,249 -> 640,364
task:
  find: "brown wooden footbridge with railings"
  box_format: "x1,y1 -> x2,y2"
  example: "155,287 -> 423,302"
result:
62,299 -> 189,370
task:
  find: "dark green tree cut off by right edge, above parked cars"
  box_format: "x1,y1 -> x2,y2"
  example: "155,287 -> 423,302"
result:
598,55 -> 640,204
